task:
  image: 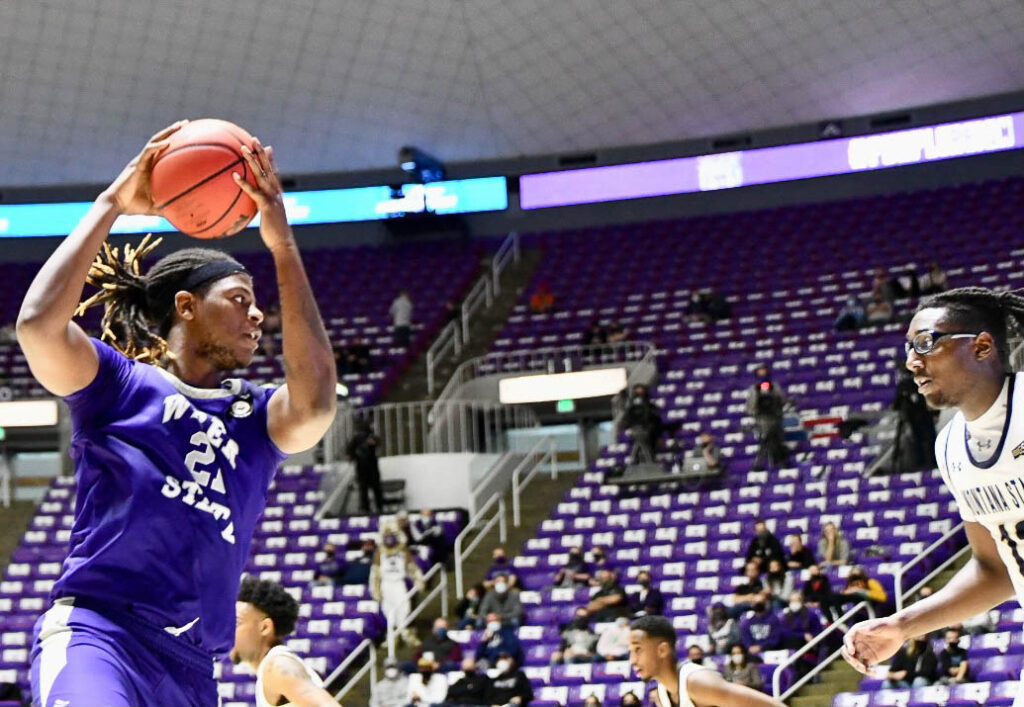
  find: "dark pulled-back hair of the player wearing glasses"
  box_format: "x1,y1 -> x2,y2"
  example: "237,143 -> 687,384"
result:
918,287 -> 1024,371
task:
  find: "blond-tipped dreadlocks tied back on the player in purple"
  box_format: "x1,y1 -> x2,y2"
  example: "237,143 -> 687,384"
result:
75,235 -> 246,366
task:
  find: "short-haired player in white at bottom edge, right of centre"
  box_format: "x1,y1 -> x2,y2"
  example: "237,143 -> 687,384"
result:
630,616 -> 785,707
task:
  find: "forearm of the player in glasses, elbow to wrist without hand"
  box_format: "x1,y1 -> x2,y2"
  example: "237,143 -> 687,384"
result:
894,557 -> 1014,637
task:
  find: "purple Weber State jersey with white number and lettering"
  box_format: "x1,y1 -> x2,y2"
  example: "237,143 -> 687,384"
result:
52,340 -> 285,654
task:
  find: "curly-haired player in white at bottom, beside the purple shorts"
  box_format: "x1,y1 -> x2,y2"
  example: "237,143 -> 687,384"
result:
231,577 -> 338,707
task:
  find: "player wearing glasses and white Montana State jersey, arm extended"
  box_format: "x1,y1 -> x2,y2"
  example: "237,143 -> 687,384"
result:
843,287 -> 1024,707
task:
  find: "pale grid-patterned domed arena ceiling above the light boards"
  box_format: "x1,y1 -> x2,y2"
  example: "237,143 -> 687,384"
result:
0,0 -> 1024,185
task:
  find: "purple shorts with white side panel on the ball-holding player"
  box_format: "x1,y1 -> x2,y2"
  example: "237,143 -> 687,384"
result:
32,599 -> 220,707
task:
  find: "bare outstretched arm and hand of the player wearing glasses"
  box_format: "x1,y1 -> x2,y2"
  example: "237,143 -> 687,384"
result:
843,523 -> 1014,673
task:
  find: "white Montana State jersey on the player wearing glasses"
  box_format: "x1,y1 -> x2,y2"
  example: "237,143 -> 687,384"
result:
935,373 -> 1024,606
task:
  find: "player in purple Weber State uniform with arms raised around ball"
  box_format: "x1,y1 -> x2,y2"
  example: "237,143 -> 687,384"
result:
17,123 -> 336,707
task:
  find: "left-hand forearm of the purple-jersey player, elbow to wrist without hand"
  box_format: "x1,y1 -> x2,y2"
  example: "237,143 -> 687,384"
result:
17,196 -> 120,336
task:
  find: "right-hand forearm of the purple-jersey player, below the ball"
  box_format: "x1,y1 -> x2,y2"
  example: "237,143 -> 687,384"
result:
271,241 -> 338,415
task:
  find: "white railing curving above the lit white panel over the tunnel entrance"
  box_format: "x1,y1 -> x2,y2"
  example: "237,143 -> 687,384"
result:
435,341 -> 656,422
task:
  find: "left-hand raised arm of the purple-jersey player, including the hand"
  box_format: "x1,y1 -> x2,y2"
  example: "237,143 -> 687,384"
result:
17,121 -> 187,396
